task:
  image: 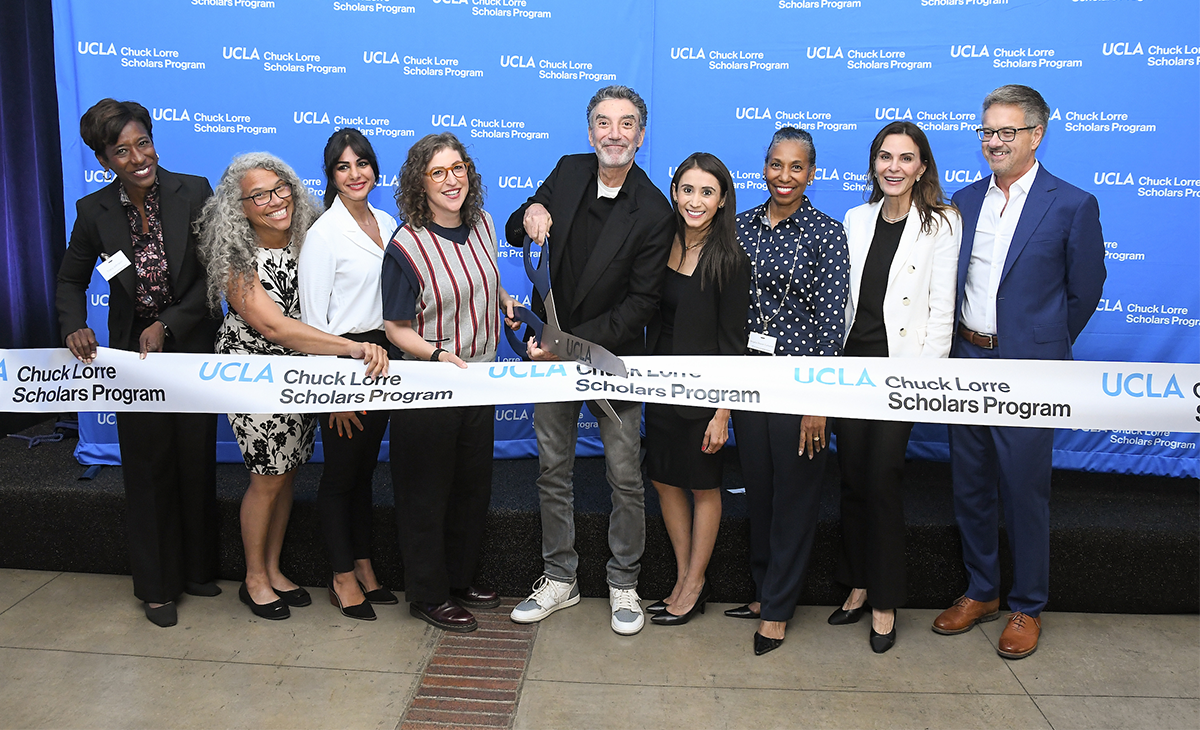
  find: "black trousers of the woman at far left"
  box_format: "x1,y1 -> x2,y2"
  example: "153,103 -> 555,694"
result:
116,413 -> 217,603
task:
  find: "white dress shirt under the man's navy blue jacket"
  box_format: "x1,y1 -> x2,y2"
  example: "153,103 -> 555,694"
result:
962,160 -> 1042,335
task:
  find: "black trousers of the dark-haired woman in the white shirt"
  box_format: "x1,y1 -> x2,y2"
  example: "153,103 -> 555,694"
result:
317,411 -> 391,573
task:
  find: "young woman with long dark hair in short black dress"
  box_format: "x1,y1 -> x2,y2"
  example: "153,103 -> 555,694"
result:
646,152 -> 750,626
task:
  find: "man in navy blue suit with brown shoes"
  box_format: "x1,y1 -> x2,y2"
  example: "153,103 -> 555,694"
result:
934,85 -> 1104,659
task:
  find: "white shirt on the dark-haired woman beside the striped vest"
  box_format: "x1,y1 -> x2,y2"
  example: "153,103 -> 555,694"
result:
299,198 -> 396,335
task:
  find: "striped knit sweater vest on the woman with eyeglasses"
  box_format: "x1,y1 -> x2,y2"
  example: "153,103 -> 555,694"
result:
390,210 -> 500,363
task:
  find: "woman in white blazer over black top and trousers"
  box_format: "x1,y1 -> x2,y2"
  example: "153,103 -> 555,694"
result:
829,121 -> 962,653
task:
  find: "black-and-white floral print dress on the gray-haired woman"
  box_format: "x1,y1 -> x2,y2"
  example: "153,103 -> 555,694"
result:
216,244 -> 317,475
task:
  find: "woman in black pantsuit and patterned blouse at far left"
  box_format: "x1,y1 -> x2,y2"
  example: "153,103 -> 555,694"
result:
56,98 -> 221,627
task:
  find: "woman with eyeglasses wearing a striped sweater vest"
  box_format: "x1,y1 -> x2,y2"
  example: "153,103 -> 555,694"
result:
383,132 -> 517,632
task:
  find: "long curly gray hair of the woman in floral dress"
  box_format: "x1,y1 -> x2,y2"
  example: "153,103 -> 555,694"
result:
197,152 -> 320,311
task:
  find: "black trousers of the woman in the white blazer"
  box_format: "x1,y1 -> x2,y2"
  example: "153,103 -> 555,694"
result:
834,418 -> 912,610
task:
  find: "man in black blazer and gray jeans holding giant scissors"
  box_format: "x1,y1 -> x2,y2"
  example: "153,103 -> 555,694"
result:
505,86 -> 676,635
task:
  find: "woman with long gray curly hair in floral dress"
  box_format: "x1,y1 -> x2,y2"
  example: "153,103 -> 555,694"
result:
200,152 -> 388,620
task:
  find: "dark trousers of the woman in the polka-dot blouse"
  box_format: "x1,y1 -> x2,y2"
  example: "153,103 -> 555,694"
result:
733,412 -> 829,621
